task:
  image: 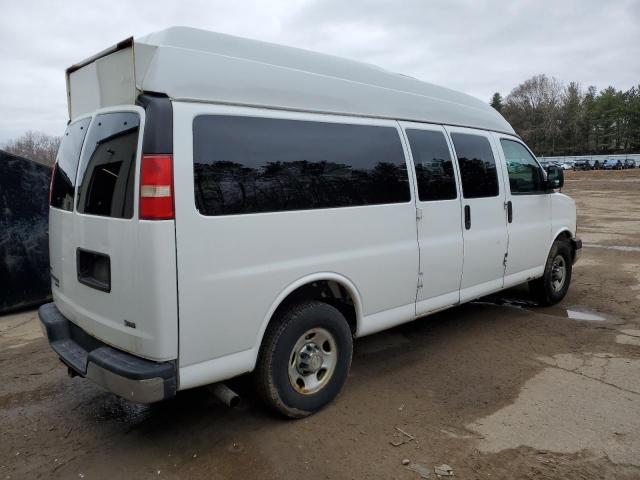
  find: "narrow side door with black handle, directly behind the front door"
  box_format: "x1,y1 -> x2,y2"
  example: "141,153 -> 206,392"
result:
446,127 -> 508,302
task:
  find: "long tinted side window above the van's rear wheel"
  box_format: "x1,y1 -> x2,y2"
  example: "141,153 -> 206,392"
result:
193,115 -> 410,215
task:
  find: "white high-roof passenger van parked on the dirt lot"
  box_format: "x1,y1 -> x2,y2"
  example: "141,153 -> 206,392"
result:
39,28 -> 581,417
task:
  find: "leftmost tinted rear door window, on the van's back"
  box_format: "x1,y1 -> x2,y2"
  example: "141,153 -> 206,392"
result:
51,118 -> 91,211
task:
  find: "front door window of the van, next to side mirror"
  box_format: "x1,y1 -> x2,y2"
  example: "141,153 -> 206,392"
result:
500,138 -> 543,194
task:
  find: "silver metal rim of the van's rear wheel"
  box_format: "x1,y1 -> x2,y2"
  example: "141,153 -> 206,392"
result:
289,328 -> 338,395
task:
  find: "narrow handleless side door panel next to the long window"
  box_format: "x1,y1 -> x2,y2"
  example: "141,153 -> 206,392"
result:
401,122 -> 463,316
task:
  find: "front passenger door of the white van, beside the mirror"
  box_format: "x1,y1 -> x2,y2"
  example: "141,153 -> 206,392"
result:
494,134 -> 551,287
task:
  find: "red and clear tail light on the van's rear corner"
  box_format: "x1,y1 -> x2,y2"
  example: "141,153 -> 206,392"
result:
140,155 -> 175,220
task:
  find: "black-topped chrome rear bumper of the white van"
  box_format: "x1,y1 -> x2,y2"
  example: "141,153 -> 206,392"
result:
38,303 -> 178,403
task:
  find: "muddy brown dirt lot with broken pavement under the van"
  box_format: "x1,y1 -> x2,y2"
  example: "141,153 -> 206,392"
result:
0,170 -> 640,479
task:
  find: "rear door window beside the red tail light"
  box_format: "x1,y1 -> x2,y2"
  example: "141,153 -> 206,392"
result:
78,112 -> 140,218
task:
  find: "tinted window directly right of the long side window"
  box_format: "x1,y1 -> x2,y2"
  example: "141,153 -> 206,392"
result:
407,129 -> 457,201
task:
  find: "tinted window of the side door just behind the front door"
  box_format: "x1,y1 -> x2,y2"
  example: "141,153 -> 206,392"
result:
451,133 -> 500,198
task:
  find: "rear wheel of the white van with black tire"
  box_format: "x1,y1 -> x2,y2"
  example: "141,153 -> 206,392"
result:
254,301 -> 353,418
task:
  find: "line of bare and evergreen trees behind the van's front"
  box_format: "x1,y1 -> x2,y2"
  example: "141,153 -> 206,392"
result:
490,75 -> 640,156
